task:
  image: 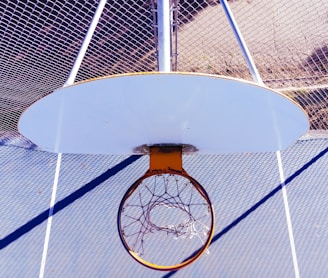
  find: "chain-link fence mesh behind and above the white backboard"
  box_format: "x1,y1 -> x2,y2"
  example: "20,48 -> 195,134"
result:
0,0 -> 328,132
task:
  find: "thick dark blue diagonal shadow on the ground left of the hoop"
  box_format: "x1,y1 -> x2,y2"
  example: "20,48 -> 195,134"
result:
0,155 -> 141,250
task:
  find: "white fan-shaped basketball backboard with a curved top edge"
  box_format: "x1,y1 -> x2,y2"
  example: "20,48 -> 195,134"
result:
18,72 -> 308,154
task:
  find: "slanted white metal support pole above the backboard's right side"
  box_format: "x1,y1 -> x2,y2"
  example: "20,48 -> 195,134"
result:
221,0 -> 263,85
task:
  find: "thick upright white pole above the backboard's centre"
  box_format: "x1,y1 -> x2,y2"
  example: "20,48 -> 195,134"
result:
157,0 -> 171,72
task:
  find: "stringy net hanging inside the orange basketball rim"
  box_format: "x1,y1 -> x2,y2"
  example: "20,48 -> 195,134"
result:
122,174 -> 210,256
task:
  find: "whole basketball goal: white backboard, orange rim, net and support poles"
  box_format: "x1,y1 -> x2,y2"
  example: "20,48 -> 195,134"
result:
18,0 -> 308,270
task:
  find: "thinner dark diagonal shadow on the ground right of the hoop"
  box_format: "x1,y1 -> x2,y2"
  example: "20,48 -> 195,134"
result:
163,147 -> 328,278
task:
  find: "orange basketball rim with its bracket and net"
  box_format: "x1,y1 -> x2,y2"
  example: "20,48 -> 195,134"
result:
118,145 -> 215,270
